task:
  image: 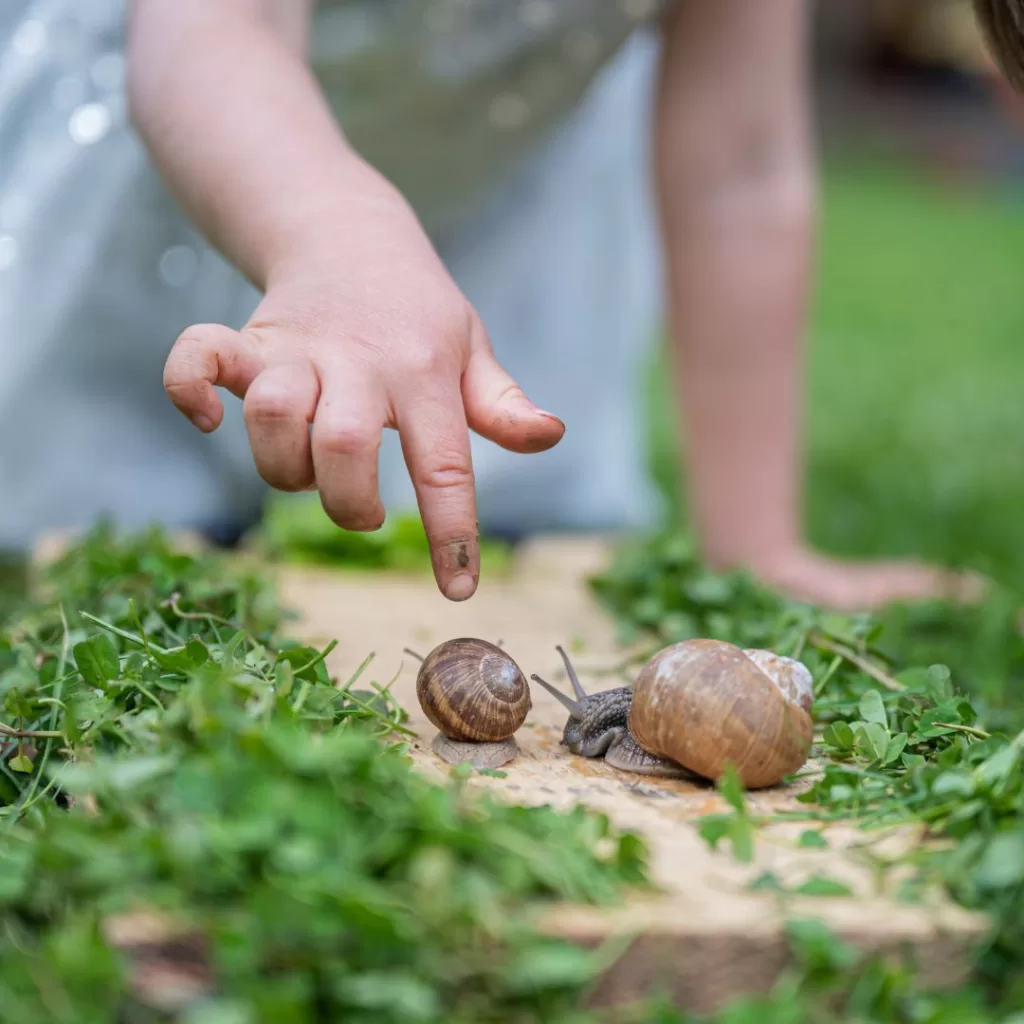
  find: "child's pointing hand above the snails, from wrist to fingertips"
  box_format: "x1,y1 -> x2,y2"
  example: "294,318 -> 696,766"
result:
164,192 -> 564,600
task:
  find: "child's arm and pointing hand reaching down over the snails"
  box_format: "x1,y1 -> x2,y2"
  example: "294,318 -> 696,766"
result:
128,0 -> 564,600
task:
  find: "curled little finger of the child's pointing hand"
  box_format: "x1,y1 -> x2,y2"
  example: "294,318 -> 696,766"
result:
164,324 -> 263,432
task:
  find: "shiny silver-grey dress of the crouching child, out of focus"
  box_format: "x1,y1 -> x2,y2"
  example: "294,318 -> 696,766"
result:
0,0 -> 660,547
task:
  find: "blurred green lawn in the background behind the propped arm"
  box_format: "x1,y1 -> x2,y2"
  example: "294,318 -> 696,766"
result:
652,160 -> 1024,592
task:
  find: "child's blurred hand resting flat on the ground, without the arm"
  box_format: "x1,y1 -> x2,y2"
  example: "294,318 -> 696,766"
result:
751,548 -> 987,612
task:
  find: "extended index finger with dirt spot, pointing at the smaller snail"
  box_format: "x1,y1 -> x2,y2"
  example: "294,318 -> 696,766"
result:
396,380 -> 480,601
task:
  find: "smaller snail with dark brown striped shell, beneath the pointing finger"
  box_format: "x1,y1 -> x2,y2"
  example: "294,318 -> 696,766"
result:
407,637 -> 531,768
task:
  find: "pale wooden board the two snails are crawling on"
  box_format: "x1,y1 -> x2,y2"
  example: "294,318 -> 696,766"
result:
279,538 -> 984,1012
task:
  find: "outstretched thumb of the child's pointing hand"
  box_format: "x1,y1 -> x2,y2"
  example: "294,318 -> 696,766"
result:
462,347 -> 565,453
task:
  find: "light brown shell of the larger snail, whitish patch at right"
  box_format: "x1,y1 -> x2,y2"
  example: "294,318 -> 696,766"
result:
629,640 -> 814,790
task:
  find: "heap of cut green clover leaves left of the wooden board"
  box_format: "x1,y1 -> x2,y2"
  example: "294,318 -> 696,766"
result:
0,526 -> 645,1024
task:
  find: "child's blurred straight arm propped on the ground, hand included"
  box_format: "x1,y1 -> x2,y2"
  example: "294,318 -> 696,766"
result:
656,0 -> 978,608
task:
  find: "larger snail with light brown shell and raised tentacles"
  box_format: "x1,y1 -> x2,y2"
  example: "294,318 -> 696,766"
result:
530,640 -> 814,790
